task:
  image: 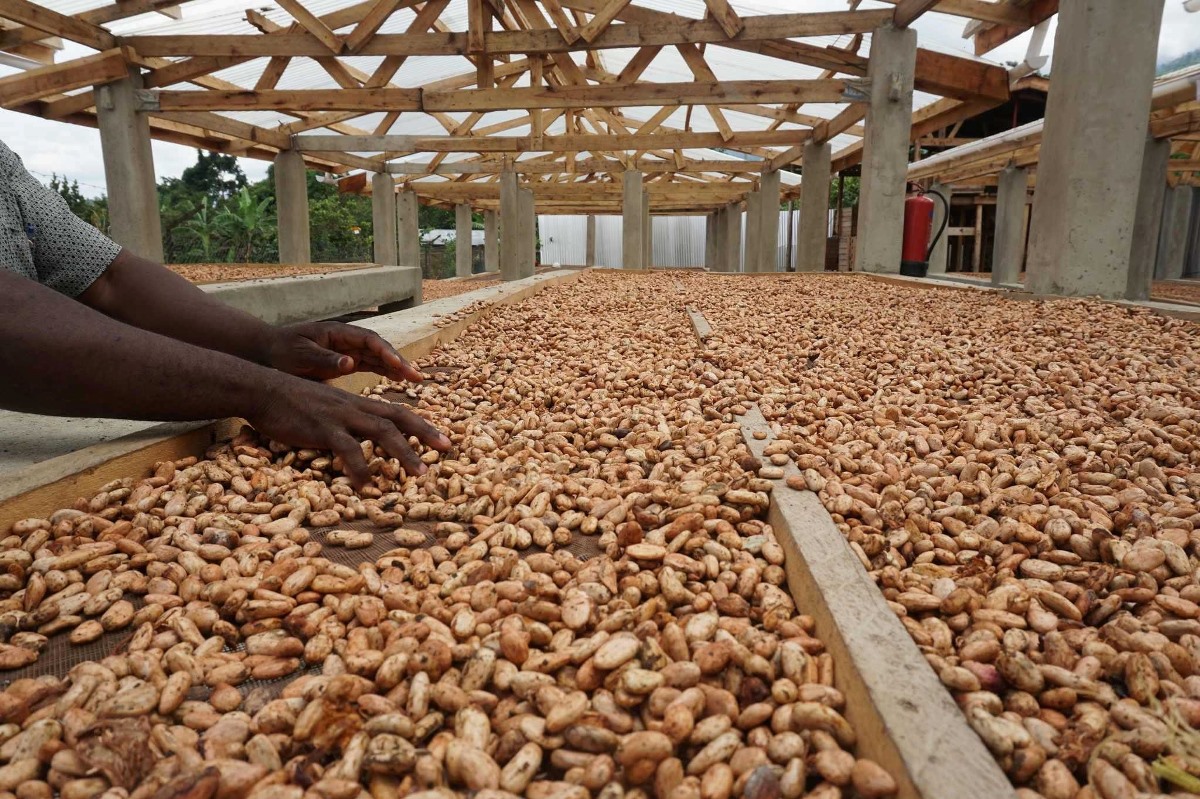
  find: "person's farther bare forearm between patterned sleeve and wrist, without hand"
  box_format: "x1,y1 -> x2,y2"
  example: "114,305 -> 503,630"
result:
79,250 -> 274,364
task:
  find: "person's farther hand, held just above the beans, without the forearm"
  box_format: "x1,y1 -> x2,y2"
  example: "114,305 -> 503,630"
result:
265,322 -> 421,383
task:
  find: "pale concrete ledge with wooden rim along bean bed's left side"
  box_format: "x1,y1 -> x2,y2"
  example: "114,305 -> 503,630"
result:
0,269 -> 582,528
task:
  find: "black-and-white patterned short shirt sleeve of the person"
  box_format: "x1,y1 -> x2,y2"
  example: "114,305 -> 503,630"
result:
0,144 -> 121,298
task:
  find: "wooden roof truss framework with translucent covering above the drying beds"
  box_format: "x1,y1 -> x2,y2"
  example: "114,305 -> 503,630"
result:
0,0 -> 1051,210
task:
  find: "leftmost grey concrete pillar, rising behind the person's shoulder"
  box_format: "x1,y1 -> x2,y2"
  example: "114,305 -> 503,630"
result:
95,68 -> 164,262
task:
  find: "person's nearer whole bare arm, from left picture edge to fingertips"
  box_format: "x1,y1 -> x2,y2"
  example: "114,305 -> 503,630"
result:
0,270 -> 450,485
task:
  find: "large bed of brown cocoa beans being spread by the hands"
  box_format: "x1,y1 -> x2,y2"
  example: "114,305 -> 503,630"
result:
0,272 -> 1200,799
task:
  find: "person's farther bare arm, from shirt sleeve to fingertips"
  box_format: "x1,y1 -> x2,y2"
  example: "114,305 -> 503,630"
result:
79,250 -> 421,382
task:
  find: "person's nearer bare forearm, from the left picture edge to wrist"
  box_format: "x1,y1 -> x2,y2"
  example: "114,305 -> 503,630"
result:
0,270 -> 283,421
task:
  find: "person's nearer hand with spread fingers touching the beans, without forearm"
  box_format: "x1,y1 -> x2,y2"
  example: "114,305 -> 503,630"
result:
247,367 -> 450,488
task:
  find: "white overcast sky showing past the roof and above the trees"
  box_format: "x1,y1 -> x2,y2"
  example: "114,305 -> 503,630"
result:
0,0 -> 1200,196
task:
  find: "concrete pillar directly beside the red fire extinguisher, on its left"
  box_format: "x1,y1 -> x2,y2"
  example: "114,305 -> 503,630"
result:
854,25 -> 917,272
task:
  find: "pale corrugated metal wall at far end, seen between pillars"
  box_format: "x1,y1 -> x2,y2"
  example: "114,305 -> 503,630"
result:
538,211 -> 833,271
